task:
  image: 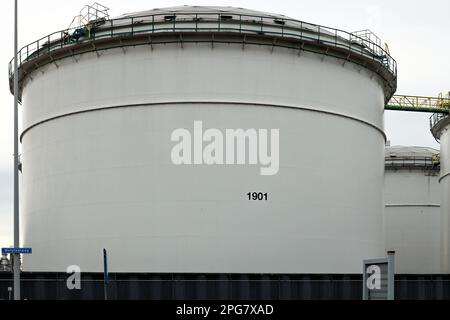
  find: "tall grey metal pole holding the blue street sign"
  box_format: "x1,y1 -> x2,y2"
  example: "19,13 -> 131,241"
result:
13,0 -> 20,300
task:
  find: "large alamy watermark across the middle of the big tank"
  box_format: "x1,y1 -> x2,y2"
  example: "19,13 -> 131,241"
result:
171,121 -> 280,176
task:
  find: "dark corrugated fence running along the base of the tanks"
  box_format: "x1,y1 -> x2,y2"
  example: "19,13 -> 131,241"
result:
0,273 -> 450,300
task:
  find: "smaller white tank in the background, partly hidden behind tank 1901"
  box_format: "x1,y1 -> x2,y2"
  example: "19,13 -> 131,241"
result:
384,146 -> 441,274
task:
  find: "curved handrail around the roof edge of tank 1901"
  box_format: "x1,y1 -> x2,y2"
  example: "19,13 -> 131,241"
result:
8,12 -> 397,82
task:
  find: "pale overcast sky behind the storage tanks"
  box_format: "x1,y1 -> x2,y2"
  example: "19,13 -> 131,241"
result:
0,0 -> 450,247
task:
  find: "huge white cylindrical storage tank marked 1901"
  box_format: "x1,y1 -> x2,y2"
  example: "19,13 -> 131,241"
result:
9,6 -> 396,273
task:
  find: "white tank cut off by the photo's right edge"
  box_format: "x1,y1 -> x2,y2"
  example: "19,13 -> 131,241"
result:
431,114 -> 450,273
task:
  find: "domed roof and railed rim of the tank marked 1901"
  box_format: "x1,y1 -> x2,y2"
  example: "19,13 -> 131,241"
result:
8,6 -> 397,103
